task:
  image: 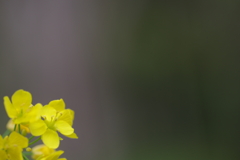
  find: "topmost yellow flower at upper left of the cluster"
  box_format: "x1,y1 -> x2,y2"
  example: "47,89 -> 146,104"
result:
3,89 -> 41,124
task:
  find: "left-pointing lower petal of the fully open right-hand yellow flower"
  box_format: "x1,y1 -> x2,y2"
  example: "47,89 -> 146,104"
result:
29,119 -> 47,136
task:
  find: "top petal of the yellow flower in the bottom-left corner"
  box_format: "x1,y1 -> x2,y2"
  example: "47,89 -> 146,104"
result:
8,131 -> 28,148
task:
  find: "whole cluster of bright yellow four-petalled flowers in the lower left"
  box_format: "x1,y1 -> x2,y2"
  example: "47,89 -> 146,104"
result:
0,89 -> 78,160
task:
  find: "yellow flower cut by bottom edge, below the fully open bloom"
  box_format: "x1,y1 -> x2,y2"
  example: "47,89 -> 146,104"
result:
32,144 -> 67,160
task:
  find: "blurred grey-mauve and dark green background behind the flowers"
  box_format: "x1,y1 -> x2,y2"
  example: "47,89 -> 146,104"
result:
0,0 -> 240,160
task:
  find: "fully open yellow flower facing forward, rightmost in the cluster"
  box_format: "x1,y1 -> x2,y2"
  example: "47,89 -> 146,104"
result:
29,99 -> 78,148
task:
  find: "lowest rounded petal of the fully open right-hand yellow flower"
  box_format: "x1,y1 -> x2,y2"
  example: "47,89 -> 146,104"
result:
42,129 -> 60,149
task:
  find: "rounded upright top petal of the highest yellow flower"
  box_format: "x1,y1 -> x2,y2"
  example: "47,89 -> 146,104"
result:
12,89 -> 32,109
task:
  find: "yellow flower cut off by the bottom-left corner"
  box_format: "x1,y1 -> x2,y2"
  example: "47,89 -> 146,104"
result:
0,131 -> 28,160
